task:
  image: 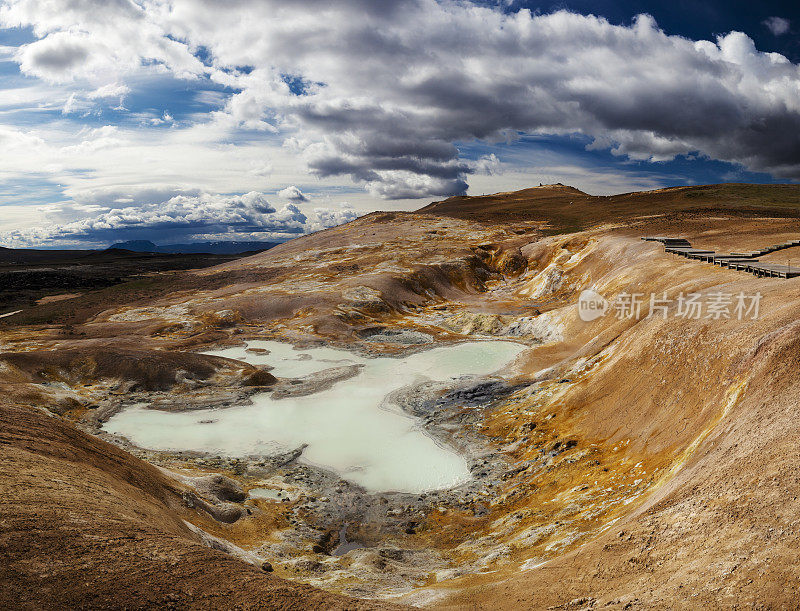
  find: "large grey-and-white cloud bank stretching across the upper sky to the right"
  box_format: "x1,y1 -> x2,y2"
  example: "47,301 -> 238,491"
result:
4,0 -> 800,198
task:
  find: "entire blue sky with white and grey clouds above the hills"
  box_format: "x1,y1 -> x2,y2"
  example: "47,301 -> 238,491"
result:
0,0 -> 800,248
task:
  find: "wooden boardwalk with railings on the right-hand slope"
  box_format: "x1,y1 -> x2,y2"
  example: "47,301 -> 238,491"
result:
642,236 -> 800,278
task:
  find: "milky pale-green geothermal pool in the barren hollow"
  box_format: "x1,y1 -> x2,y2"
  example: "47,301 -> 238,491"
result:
103,341 -> 525,493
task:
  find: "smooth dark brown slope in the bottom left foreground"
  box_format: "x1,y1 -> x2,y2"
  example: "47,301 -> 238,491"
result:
0,394 -> 398,609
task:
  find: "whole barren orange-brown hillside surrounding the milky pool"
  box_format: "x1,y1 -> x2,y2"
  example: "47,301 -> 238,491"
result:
0,185 -> 800,609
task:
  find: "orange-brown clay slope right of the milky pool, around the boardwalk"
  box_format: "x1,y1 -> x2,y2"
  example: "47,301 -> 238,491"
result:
408,190 -> 800,609
